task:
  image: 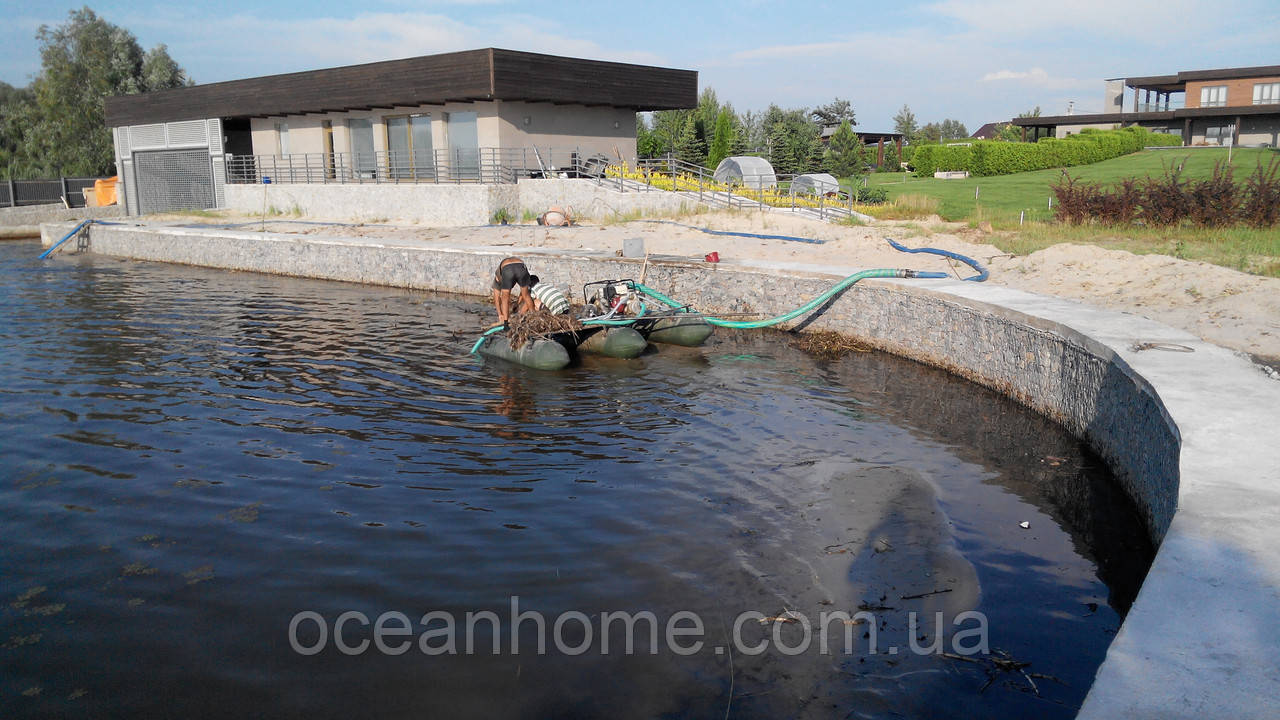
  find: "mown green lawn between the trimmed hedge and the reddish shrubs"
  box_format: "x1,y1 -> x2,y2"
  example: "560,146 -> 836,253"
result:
868,147 -> 1280,228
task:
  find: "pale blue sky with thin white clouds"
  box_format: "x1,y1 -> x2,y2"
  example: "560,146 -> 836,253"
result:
0,0 -> 1280,132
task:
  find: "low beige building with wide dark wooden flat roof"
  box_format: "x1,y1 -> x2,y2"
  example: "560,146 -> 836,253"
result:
106,47 -> 698,214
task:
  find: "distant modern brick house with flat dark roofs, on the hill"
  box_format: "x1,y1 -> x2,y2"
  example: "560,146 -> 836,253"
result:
1010,65 -> 1280,147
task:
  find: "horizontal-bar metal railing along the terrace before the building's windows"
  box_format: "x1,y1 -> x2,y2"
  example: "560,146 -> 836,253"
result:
227,147 -> 624,184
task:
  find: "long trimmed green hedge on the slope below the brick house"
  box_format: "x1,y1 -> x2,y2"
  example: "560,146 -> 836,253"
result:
913,127 -> 1183,178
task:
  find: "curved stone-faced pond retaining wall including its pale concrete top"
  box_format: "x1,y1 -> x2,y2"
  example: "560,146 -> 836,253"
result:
37,225 -> 1280,720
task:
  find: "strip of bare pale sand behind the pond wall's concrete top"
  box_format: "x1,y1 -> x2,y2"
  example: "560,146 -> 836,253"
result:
152,211 -> 1280,366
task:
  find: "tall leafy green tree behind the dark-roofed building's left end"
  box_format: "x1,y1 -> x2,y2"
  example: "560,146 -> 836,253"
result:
0,8 -> 191,177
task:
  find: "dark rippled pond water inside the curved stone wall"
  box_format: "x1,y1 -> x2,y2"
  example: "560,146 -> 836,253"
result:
0,242 -> 1151,717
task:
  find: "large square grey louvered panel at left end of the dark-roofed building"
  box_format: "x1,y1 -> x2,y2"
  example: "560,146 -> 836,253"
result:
133,149 -> 216,214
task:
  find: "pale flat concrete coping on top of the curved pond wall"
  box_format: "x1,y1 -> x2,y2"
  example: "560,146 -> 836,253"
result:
35,223 -> 1280,719
